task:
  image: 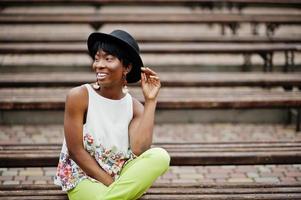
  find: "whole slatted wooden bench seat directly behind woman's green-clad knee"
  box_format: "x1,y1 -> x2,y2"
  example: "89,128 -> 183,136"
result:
0,141 -> 301,167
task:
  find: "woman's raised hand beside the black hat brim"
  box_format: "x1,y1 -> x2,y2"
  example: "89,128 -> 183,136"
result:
141,67 -> 161,101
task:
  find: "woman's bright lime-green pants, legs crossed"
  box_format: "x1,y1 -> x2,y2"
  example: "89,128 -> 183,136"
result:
68,148 -> 170,200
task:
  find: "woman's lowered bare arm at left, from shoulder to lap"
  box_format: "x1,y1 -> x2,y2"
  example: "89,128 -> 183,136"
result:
64,86 -> 113,186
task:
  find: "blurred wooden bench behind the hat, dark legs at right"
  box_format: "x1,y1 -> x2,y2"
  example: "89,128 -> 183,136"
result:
0,43 -> 301,71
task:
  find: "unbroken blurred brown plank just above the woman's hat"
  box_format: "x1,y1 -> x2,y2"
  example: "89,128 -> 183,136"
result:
0,13 -> 301,25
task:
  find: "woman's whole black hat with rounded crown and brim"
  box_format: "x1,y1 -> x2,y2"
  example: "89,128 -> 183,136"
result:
87,30 -> 143,83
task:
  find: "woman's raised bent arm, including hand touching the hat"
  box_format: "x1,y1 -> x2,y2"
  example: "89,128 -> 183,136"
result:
129,68 -> 161,155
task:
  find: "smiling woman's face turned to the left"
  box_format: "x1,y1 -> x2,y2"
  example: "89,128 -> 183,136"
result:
92,50 -> 126,87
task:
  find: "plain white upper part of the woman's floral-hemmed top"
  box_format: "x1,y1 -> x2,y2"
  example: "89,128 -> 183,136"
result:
83,84 -> 133,154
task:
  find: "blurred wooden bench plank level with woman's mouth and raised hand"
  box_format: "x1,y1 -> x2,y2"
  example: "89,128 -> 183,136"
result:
0,72 -> 301,88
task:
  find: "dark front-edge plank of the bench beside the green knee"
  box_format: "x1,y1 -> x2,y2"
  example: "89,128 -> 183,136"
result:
0,150 -> 301,167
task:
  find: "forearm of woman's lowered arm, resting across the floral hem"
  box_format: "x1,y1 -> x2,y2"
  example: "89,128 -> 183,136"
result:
69,149 -> 113,186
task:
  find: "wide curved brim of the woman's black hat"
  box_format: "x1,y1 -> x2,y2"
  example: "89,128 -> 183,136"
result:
87,32 -> 143,83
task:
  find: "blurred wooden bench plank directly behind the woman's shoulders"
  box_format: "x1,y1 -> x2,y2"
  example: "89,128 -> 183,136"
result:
0,87 -> 301,110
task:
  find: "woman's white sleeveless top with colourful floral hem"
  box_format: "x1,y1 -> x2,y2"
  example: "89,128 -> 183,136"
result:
54,84 -> 135,191
